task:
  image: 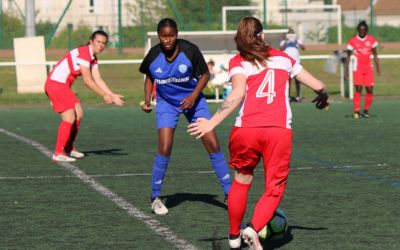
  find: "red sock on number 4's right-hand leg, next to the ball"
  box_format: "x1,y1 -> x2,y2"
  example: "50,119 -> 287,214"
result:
251,193 -> 282,232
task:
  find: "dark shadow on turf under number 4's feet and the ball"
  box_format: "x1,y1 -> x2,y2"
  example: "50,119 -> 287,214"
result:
199,226 -> 328,250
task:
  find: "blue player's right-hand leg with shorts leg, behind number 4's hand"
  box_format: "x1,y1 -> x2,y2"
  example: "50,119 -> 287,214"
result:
184,98 -> 231,198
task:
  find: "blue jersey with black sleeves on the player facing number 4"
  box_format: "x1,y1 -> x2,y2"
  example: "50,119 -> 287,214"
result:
139,39 -> 208,107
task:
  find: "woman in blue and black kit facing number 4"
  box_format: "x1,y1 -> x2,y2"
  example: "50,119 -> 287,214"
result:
139,18 -> 231,214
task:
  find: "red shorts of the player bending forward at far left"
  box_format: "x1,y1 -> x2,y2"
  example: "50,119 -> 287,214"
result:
44,80 -> 79,113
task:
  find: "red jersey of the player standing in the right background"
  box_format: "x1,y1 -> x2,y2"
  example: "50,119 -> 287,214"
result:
347,35 -> 378,71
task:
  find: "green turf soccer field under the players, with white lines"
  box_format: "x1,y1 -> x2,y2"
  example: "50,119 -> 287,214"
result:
0,99 -> 400,250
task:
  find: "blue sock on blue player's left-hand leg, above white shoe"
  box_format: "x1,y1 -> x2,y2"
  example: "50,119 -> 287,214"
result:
151,154 -> 170,199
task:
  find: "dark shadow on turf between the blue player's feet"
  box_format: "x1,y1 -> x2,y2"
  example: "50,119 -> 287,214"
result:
160,193 -> 226,209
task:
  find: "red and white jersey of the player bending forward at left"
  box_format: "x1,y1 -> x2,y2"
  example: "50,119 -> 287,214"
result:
48,45 -> 98,86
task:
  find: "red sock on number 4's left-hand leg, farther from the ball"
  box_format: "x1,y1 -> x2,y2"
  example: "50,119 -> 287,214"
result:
228,180 -> 251,235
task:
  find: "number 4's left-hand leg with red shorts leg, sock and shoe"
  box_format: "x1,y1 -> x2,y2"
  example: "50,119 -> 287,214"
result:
228,127 -> 261,247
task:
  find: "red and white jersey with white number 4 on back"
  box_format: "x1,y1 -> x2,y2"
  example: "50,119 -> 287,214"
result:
229,48 -> 303,128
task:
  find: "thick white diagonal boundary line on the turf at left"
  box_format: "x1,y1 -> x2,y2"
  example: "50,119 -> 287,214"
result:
0,128 -> 196,250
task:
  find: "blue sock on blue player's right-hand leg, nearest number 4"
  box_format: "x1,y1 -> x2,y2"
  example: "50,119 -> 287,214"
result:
210,150 -> 231,195
